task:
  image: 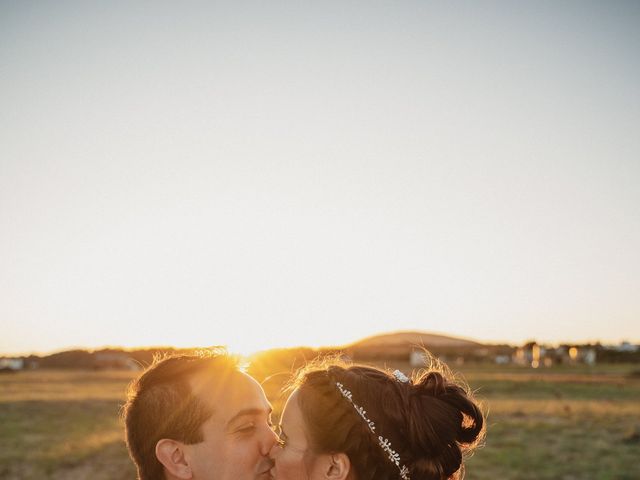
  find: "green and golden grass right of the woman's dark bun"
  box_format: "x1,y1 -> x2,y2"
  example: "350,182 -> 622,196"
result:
452,368 -> 640,480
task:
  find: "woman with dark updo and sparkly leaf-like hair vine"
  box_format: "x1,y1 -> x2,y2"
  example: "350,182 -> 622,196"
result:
271,361 -> 484,480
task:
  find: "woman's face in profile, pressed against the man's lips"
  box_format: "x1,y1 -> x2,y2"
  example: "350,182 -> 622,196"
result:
271,389 -> 323,480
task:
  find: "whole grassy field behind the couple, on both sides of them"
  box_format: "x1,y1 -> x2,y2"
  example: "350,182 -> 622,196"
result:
0,364 -> 640,480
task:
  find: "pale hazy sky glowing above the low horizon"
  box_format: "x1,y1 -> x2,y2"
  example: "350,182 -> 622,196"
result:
0,1 -> 640,354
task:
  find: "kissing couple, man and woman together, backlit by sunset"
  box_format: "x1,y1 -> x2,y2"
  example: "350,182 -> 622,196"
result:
123,352 -> 485,480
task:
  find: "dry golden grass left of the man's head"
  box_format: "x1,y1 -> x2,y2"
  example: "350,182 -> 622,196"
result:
0,371 -> 135,480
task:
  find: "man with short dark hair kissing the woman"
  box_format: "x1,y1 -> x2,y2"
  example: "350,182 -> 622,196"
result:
123,352 -> 276,480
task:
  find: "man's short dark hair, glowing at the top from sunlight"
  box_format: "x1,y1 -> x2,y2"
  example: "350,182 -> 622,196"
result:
122,350 -> 239,480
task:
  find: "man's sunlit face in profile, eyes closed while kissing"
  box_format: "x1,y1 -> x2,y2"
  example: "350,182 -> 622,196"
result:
185,372 -> 276,480
